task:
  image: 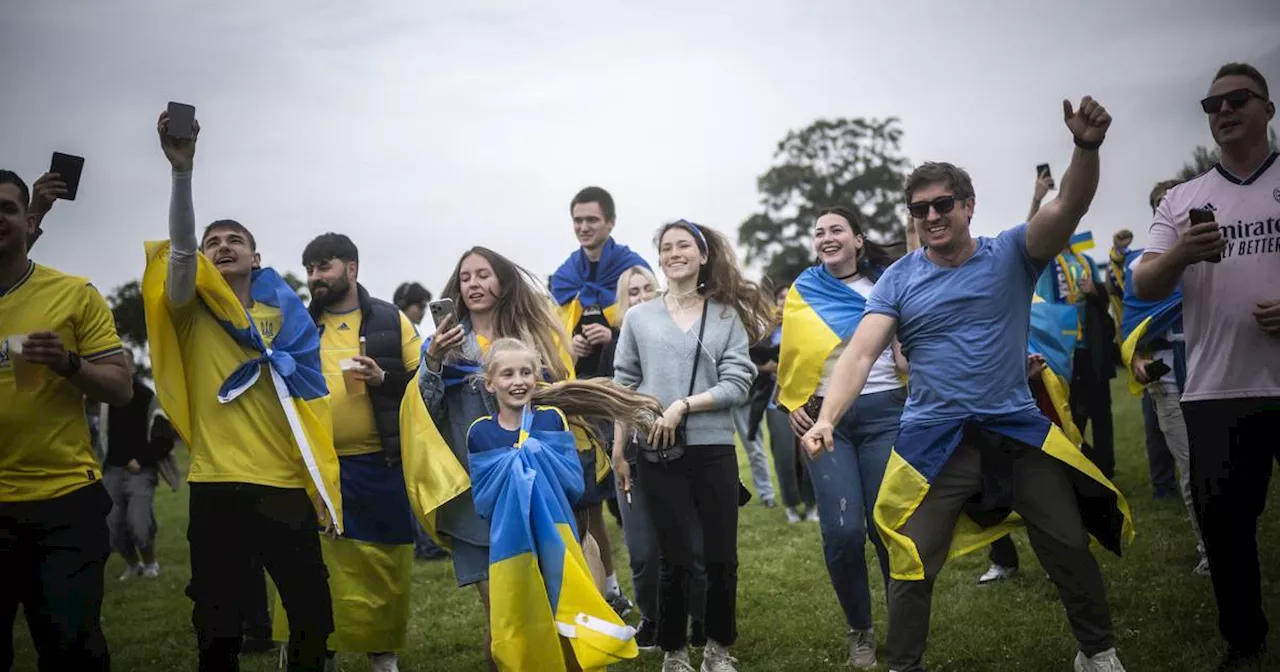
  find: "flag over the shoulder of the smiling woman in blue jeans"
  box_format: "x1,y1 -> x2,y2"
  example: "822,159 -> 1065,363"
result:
778,264 -> 867,411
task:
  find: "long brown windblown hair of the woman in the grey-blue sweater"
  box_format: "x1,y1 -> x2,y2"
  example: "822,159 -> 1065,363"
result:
654,219 -> 777,343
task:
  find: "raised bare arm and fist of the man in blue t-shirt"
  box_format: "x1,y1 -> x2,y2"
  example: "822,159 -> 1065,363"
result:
1027,96 -> 1111,261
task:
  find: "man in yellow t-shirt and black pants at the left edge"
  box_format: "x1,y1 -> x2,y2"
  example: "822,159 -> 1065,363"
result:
0,170 -> 133,671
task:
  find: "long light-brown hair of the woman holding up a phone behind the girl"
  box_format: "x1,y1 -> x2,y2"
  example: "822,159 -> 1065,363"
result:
444,246 -> 571,380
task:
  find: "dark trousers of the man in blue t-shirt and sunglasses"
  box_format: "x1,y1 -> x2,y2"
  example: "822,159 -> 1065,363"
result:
886,440 -> 1112,672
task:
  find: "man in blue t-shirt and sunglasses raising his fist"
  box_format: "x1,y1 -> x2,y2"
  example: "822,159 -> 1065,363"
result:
804,97 -> 1124,672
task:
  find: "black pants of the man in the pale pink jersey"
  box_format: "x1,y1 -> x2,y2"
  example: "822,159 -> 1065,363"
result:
1183,398 -> 1280,653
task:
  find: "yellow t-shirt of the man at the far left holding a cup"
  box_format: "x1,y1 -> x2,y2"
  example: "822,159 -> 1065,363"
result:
0,264 -> 122,502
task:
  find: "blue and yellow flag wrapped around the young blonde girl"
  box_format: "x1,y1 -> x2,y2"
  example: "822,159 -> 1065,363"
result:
470,407 -> 639,671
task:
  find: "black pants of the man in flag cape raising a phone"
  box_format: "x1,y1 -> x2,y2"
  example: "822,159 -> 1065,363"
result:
187,483 -> 333,672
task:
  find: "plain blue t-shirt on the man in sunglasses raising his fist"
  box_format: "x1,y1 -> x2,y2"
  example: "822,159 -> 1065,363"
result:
867,224 -> 1044,425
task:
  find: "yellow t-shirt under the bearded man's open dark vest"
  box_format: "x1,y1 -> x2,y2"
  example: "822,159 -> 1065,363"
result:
320,308 -> 422,456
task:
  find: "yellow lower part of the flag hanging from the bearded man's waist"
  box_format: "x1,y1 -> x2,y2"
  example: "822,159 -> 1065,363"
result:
271,536 -> 413,653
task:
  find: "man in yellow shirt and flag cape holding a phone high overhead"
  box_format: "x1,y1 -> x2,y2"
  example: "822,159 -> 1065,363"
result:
142,115 -> 342,672
